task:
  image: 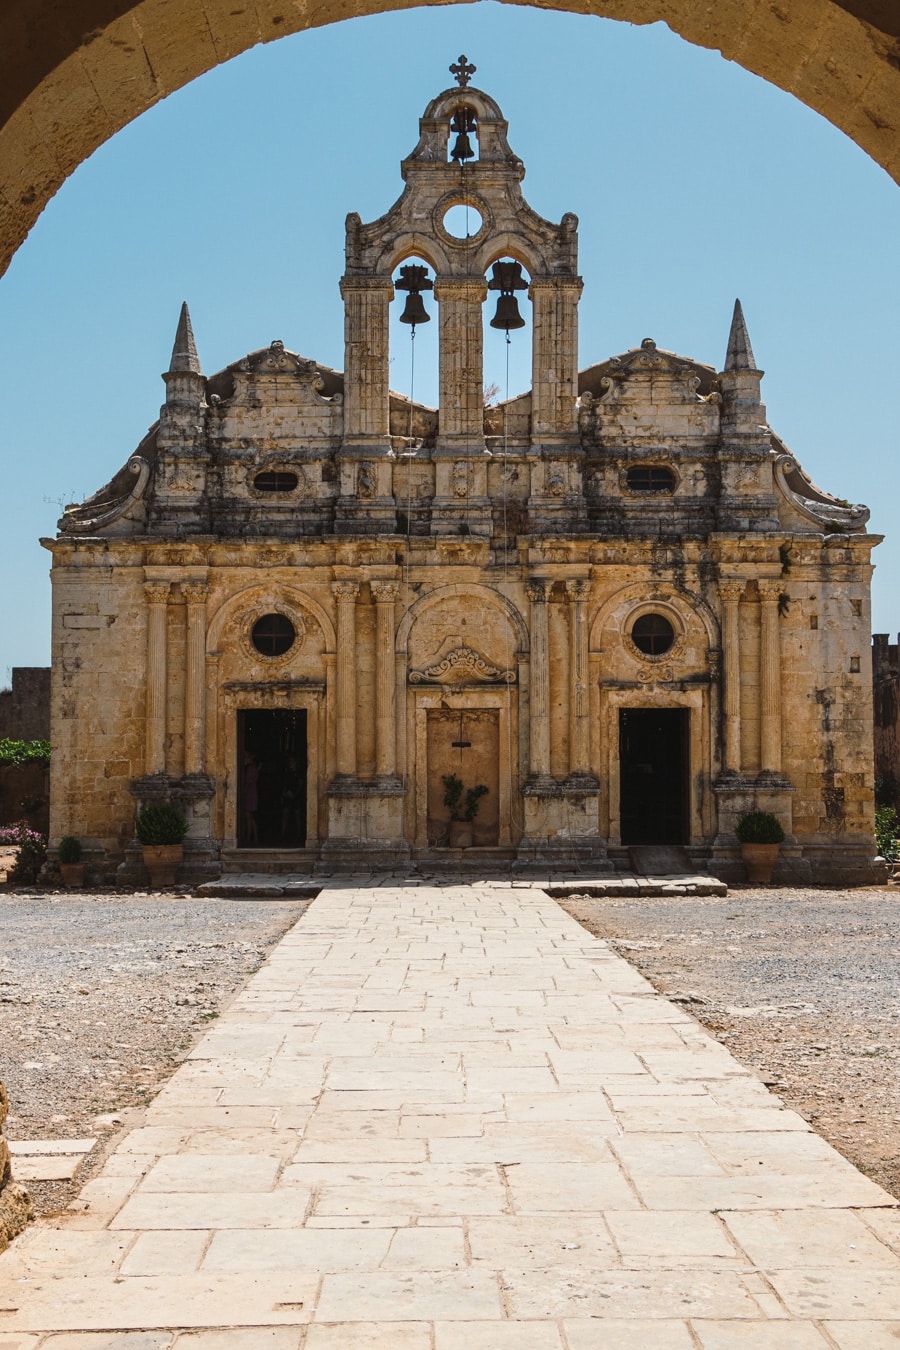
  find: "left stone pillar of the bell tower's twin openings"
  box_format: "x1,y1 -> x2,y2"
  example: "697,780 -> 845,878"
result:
340,275 -> 394,443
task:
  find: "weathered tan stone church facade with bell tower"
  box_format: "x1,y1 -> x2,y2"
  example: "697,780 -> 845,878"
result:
43,58 -> 878,882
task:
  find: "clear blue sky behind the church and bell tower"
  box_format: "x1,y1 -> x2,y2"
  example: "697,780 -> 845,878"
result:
0,3 -> 900,684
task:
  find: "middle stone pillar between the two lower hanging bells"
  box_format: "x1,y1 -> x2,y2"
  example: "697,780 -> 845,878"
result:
434,277 -> 487,451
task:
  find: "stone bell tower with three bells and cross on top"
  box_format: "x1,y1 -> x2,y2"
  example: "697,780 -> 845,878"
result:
337,57 -> 584,535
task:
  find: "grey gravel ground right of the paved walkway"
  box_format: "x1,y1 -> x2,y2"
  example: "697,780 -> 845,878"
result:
561,887 -> 900,1199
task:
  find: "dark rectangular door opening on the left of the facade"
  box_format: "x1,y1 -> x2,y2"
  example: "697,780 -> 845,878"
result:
237,707 -> 306,848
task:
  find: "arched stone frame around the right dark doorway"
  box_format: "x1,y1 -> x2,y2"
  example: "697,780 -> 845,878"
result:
588,579 -> 721,848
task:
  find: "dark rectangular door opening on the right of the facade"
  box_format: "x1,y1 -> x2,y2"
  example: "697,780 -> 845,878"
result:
619,707 -> 690,844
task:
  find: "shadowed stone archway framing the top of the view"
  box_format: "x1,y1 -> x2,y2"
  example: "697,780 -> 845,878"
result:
0,0 -> 900,274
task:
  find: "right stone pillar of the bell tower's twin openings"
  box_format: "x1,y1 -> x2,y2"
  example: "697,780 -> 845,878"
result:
529,277 -> 582,441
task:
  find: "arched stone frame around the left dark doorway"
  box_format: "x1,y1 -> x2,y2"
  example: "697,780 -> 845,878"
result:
206,579 -> 335,848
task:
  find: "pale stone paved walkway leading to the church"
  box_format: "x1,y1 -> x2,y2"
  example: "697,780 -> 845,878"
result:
0,886 -> 900,1350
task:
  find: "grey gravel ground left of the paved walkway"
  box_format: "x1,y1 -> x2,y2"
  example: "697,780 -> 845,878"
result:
0,892 -> 308,1214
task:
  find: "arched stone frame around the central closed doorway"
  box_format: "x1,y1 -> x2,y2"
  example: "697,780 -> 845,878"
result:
395,582 -> 529,848
